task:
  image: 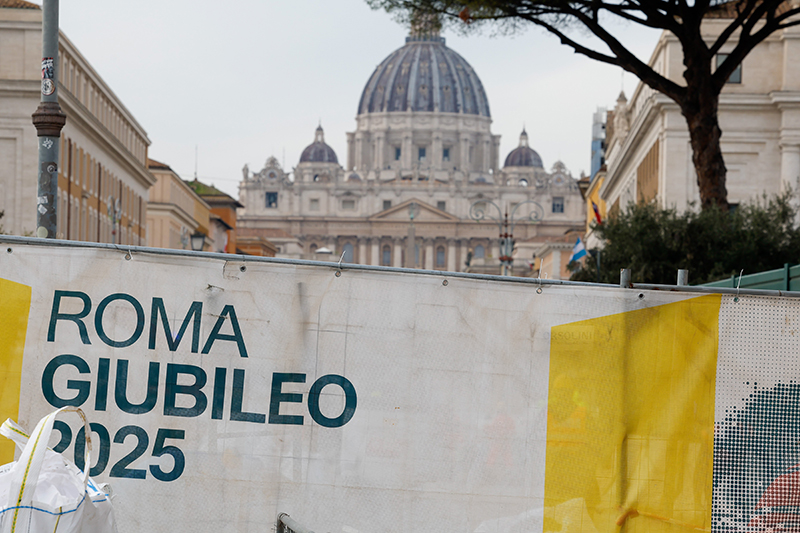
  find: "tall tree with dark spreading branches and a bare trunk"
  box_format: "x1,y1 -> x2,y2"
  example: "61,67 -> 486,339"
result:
367,0 -> 800,209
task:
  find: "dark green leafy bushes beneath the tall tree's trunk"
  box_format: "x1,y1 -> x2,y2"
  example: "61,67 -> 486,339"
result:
570,193 -> 800,285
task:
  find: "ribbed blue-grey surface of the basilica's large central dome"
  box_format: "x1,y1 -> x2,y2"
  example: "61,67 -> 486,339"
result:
358,36 -> 491,117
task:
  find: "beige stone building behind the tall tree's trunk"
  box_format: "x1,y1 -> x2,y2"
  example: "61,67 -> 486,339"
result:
587,18 -> 800,223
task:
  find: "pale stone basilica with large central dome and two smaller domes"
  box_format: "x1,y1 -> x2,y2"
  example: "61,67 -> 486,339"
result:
238,26 -> 584,275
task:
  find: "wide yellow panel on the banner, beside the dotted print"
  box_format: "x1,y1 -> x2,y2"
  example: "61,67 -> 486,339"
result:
544,295 -> 721,533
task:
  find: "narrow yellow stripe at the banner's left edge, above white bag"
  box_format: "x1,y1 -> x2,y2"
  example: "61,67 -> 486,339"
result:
0,279 -> 31,464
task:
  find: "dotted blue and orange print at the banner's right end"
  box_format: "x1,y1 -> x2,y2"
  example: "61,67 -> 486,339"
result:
711,296 -> 800,533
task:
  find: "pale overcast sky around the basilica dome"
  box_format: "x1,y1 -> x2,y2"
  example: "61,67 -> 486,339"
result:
39,0 -> 658,198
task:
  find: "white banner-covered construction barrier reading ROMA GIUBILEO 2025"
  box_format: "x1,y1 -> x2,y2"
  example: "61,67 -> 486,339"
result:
0,238 -> 800,533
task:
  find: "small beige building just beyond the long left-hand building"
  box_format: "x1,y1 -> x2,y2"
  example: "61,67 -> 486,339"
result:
147,159 -> 213,250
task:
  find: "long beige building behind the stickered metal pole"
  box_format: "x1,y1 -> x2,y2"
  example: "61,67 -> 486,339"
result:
0,0 -> 155,244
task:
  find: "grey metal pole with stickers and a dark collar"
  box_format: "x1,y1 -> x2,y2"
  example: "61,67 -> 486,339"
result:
31,0 -> 67,239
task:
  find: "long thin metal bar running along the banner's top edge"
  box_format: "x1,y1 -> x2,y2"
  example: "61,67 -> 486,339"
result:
0,235 -> 800,298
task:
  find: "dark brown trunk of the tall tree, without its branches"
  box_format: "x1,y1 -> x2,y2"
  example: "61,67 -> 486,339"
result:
678,41 -> 728,211
